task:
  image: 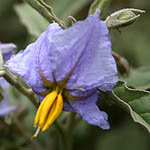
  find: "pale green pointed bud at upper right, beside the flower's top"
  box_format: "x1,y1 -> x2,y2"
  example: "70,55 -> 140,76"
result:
105,8 -> 145,29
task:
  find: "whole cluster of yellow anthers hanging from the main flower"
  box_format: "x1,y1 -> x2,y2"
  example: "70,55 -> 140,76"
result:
34,87 -> 63,132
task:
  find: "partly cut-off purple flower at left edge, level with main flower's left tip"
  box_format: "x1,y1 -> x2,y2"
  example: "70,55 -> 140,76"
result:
0,42 -> 17,61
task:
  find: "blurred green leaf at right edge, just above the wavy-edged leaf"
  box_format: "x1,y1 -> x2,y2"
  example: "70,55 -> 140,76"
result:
121,67 -> 150,90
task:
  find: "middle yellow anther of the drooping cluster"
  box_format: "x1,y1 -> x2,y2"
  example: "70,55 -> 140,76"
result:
39,91 -> 57,128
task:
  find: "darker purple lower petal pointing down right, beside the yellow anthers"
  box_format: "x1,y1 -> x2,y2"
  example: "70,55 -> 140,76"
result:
64,89 -> 110,129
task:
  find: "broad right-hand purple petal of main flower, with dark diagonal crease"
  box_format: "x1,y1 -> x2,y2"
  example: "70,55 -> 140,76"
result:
46,12 -> 118,90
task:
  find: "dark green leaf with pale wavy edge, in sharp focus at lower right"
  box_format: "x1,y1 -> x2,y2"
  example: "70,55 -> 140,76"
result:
100,81 -> 150,133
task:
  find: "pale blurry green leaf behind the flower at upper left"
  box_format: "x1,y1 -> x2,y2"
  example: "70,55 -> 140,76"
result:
15,3 -> 49,37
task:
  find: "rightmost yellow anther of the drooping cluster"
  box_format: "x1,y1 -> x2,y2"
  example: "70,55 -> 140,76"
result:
42,93 -> 63,132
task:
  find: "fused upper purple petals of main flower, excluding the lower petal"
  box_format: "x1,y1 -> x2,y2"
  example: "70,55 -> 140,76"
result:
7,12 -> 118,90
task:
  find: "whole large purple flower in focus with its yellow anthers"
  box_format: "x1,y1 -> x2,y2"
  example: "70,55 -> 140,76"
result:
6,11 -> 118,131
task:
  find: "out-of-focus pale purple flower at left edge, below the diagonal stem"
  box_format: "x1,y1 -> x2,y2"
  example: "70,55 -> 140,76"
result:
0,78 -> 17,117
